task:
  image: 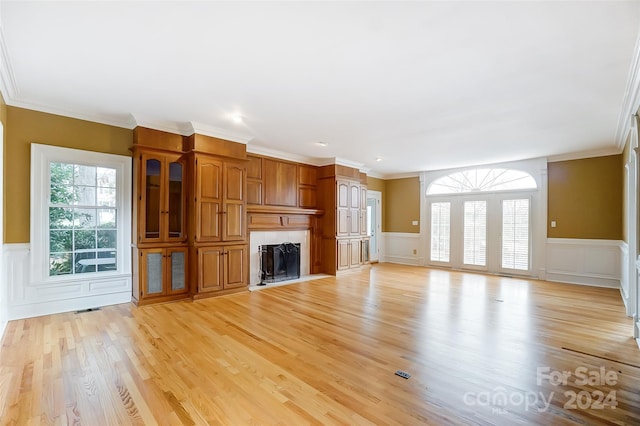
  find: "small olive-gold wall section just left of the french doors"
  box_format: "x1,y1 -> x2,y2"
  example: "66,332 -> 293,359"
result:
382,177 -> 420,233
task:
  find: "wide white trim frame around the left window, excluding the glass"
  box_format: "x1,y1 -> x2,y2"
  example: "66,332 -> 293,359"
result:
30,143 -> 132,284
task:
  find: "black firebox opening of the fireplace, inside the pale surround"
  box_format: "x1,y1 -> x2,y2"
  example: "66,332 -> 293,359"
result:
258,243 -> 300,285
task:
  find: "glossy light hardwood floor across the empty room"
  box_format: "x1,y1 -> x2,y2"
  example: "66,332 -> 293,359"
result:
0,264 -> 640,426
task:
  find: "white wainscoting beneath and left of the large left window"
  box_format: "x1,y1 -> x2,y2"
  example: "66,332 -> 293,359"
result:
2,244 -> 131,320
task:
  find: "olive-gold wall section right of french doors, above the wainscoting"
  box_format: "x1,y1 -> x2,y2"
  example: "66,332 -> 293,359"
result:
547,154 -> 624,240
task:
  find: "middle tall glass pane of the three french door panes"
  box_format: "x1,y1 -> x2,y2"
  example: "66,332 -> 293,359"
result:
464,201 -> 487,266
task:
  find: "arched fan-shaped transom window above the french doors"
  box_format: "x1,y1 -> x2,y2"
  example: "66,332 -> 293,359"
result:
427,169 -> 537,195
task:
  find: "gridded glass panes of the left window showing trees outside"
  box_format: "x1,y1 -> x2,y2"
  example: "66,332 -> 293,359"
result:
49,162 -> 117,276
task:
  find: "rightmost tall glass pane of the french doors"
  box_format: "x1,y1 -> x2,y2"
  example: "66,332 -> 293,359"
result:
502,199 -> 529,271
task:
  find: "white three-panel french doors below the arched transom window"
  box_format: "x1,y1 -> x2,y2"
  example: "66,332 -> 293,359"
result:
428,193 -> 533,275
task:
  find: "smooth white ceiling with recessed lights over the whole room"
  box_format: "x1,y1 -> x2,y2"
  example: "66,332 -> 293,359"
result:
0,1 -> 640,177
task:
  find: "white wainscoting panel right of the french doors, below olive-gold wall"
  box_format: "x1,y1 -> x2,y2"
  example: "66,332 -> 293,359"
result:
546,238 -> 625,288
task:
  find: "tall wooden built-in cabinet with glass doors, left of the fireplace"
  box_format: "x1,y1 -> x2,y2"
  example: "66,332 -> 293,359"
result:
133,127 -> 249,304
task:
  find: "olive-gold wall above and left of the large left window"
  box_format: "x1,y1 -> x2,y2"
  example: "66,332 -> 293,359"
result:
4,106 -> 133,243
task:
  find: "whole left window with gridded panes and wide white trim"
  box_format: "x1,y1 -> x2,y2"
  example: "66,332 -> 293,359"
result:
31,144 -> 131,282
